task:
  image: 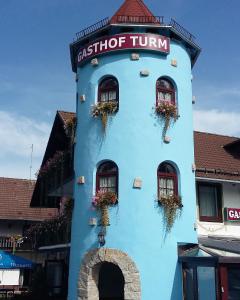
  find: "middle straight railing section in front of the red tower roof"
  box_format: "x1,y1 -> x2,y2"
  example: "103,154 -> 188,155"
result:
113,15 -> 163,24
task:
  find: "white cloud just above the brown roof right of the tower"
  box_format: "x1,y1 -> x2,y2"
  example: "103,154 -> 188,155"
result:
194,109 -> 240,136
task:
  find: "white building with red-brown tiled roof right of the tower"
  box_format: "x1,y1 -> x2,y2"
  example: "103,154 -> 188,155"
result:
195,132 -> 240,300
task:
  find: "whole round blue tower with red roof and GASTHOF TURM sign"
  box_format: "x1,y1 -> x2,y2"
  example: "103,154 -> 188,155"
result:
68,0 -> 200,300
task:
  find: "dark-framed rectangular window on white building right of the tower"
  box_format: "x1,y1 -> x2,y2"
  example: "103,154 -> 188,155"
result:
197,182 -> 222,222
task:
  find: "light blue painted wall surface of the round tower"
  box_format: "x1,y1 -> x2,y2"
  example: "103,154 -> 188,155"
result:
69,42 -> 197,300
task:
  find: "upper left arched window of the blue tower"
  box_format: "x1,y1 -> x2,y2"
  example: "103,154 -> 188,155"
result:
98,76 -> 119,102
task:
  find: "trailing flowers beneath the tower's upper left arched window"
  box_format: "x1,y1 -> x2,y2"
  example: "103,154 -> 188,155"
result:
92,101 -> 118,133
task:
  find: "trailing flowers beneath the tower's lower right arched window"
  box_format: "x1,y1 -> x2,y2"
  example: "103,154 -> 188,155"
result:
158,195 -> 183,233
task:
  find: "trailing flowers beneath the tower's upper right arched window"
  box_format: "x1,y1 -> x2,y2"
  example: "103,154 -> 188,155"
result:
155,101 -> 179,139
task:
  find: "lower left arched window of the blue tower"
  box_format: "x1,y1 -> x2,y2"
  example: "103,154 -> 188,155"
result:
96,161 -> 118,194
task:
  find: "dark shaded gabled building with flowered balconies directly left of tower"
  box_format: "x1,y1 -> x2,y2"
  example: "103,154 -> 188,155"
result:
30,111 -> 76,297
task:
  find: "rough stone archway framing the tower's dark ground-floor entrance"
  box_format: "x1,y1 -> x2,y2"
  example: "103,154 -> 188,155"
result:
78,248 -> 141,300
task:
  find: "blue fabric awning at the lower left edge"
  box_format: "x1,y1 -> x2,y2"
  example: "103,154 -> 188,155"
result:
0,250 -> 34,269
